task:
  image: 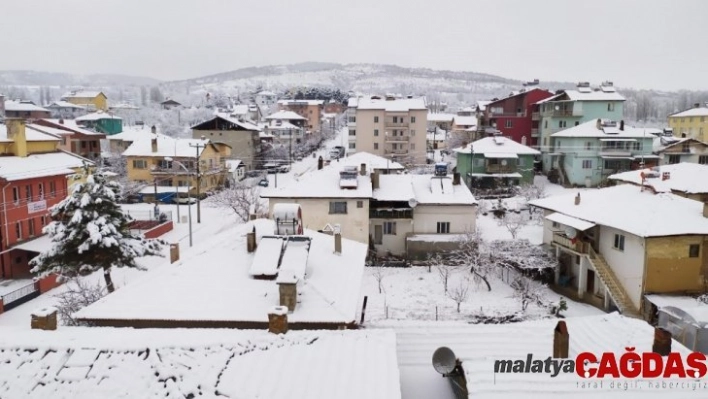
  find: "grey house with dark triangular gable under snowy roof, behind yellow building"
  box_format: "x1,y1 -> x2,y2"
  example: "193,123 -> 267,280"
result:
192,114 -> 261,169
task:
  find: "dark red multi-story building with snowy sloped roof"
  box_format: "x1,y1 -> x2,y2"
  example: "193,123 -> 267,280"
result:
479,88 -> 553,147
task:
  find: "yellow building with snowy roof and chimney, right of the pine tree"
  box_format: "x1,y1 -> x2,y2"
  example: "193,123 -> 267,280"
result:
123,135 -> 231,201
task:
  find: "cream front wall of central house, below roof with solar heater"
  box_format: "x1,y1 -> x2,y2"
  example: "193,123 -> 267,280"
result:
268,198 -> 369,244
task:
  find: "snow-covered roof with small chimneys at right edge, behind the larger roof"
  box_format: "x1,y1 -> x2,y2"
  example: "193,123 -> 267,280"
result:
608,162 -> 708,194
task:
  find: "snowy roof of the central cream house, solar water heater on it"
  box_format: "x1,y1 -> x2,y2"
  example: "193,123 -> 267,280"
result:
261,162 -> 371,198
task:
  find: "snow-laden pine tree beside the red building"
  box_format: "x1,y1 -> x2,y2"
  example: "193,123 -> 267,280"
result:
30,170 -> 165,292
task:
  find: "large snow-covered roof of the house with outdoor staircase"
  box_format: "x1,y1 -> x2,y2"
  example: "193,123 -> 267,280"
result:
529,184 -> 708,237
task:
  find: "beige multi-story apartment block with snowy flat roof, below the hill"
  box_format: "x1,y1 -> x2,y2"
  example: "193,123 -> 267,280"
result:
349,98 -> 428,164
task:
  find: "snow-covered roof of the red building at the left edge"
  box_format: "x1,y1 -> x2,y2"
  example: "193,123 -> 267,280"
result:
0,151 -> 92,181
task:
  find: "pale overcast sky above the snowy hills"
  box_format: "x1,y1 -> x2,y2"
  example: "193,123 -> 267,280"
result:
0,0 -> 708,89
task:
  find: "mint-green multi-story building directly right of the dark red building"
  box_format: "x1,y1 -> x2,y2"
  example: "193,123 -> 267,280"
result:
531,82 -> 625,173
